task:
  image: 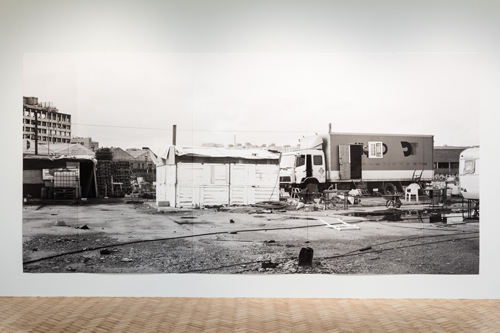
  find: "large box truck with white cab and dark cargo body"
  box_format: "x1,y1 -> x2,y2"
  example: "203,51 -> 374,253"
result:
280,127 -> 434,195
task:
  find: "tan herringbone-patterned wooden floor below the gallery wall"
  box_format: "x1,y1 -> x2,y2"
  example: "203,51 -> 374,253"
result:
0,297 -> 500,333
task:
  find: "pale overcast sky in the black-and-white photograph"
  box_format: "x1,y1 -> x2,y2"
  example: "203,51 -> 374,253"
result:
23,53 -> 480,149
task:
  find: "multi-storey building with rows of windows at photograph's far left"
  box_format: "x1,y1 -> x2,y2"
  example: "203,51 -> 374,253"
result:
23,97 -> 71,143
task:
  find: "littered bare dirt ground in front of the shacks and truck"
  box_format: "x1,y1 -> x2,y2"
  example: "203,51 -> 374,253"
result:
23,198 -> 479,274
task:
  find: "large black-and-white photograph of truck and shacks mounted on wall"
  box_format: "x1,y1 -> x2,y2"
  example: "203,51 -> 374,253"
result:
19,53 -> 480,275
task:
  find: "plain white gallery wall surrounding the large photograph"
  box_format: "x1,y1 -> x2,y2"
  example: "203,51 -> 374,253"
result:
0,0 -> 500,298
